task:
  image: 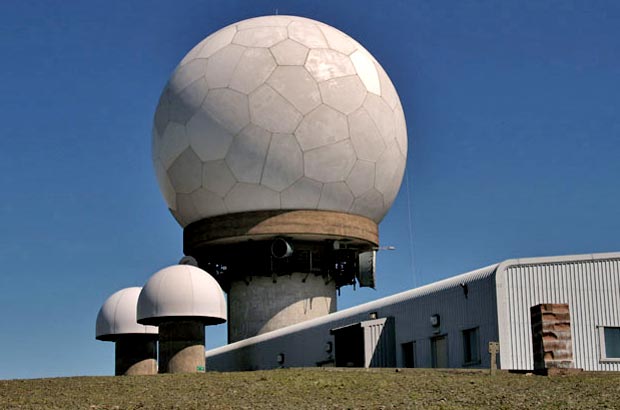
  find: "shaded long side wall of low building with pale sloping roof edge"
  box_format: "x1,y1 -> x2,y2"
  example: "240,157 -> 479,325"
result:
207,265 -> 498,371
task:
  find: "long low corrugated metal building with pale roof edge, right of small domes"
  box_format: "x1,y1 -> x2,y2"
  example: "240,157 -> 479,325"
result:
207,253 -> 620,371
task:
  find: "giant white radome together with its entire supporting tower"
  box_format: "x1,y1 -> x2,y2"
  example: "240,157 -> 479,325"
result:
153,16 -> 407,342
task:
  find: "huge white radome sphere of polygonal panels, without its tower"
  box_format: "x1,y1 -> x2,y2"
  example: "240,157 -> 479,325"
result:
153,16 -> 407,226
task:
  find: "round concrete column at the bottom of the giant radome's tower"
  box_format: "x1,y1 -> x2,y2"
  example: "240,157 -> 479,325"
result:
228,273 -> 336,343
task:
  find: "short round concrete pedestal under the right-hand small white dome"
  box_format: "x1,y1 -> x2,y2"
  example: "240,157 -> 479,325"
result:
159,320 -> 205,373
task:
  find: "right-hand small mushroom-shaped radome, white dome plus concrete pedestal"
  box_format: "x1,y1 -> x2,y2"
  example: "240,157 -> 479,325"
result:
137,265 -> 226,373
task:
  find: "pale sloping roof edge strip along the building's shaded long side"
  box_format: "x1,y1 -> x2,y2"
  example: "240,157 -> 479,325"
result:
206,264 -> 499,357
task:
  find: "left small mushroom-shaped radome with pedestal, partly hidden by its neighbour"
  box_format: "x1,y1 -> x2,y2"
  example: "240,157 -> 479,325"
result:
96,287 -> 157,376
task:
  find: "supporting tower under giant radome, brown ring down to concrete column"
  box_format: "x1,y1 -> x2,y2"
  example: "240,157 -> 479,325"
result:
184,210 -> 379,343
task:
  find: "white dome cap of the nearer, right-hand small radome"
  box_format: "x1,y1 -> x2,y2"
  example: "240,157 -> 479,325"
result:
138,265 -> 226,325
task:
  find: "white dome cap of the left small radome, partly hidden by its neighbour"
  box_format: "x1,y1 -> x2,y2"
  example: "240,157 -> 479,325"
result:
96,287 -> 157,341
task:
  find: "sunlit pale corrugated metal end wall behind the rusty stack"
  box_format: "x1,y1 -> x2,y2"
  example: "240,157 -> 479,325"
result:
497,254 -> 620,371
